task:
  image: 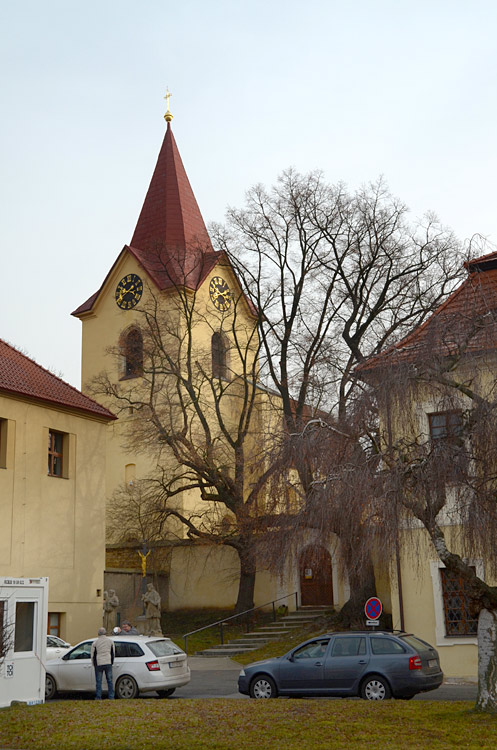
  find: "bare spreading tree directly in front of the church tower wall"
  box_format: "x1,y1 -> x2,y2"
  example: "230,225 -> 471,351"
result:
92,253 -> 280,611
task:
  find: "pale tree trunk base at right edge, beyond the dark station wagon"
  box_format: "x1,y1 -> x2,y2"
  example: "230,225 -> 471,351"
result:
475,609 -> 497,713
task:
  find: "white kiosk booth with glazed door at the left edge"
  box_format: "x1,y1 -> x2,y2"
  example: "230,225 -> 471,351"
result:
0,577 -> 48,707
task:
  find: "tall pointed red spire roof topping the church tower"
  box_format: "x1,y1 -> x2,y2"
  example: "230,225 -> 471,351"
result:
72,122 -> 223,316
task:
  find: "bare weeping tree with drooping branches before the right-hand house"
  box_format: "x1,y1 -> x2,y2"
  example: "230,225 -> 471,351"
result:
350,255 -> 497,712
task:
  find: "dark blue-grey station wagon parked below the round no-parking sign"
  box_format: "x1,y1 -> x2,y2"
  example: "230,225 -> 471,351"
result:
238,631 -> 443,701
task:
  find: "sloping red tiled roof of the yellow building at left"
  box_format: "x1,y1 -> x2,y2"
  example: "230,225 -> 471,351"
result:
0,339 -> 116,420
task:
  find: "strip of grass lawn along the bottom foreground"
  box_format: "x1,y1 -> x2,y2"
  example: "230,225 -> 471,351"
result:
0,699 -> 497,750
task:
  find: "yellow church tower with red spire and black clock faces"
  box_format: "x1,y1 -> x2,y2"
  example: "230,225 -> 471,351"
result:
72,101 -> 264,608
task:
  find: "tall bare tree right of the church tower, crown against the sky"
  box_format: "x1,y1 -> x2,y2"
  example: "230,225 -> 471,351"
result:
212,170 -> 461,624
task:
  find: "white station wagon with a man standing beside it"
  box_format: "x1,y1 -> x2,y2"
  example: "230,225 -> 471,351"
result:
45,635 -> 190,700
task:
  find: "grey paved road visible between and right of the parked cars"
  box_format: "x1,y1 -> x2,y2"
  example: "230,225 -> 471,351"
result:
170,656 -> 476,701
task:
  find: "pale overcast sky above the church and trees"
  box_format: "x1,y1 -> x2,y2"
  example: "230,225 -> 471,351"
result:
0,0 -> 497,387
